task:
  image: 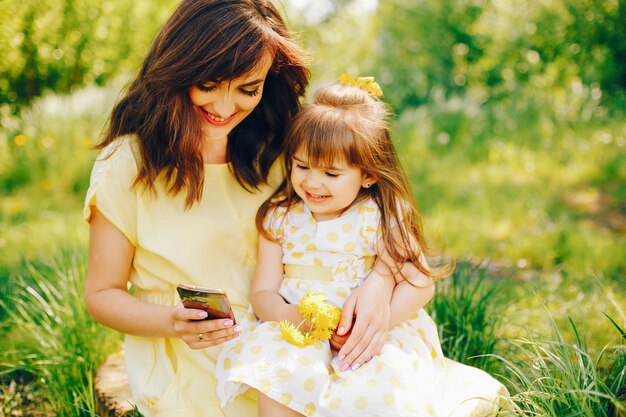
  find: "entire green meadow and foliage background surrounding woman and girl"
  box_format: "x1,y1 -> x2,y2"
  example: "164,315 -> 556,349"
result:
0,0 -> 626,417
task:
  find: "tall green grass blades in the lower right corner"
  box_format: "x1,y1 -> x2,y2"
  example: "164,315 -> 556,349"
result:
490,316 -> 626,417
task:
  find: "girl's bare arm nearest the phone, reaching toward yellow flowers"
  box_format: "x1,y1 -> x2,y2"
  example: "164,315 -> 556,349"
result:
250,235 -> 303,326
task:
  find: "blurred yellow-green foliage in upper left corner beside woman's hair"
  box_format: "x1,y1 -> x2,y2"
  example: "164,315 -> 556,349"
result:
0,0 -> 176,114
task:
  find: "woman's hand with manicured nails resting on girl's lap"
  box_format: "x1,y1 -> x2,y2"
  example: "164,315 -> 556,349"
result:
333,274 -> 395,370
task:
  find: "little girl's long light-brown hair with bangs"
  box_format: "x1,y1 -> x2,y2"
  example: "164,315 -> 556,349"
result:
256,84 -> 446,279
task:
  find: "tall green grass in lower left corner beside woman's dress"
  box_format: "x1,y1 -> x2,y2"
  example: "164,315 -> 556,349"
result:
0,248 -> 120,417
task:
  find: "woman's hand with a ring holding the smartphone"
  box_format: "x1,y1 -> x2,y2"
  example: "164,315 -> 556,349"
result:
172,303 -> 241,349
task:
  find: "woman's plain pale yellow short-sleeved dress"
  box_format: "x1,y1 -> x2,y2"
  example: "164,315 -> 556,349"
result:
84,137 -> 284,417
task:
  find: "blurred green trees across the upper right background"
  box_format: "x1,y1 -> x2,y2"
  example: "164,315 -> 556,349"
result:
372,0 -> 626,111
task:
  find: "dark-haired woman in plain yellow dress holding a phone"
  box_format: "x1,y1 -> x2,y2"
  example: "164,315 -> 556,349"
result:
84,0 -> 393,417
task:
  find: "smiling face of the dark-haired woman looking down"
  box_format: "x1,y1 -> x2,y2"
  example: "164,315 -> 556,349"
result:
189,55 -> 272,139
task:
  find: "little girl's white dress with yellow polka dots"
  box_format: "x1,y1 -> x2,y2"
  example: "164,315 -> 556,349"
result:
216,200 -> 445,417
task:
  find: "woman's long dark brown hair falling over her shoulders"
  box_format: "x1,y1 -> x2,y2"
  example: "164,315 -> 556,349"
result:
98,0 -> 309,207
